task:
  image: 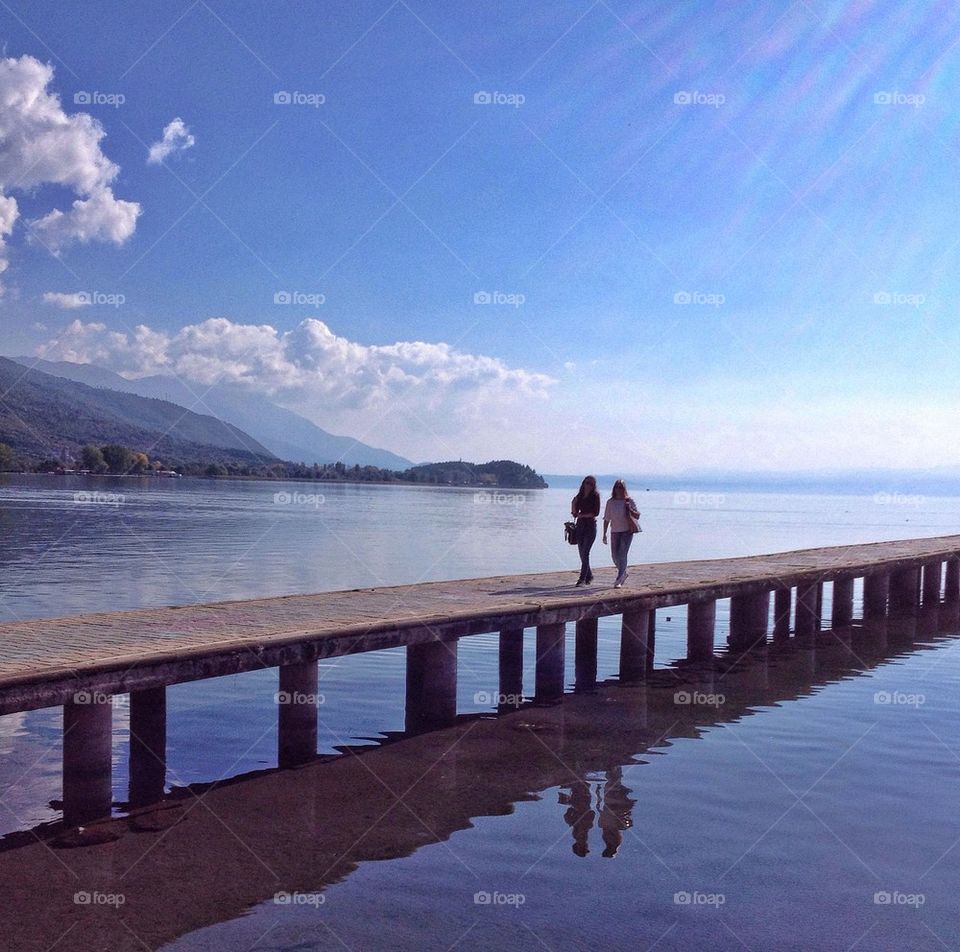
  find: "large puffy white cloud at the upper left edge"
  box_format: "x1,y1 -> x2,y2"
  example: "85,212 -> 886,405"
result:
0,56 -> 140,272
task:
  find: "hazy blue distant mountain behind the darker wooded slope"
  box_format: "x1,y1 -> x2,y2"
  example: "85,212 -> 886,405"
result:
13,357 -> 413,470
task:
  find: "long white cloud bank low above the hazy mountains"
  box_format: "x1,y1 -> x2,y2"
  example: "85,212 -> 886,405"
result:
38,318 -> 555,457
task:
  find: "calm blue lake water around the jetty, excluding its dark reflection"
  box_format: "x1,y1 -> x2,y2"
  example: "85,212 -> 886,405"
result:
0,477 -> 960,950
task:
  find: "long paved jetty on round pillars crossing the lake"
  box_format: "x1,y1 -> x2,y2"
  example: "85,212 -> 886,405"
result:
0,535 -> 960,825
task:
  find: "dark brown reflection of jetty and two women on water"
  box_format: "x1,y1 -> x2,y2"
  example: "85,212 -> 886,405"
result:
0,619 -> 951,952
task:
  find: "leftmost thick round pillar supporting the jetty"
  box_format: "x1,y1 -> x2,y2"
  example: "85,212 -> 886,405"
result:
63,691 -> 113,826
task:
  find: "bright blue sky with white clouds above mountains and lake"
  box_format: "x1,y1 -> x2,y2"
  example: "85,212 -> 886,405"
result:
0,0 -> 960,474
